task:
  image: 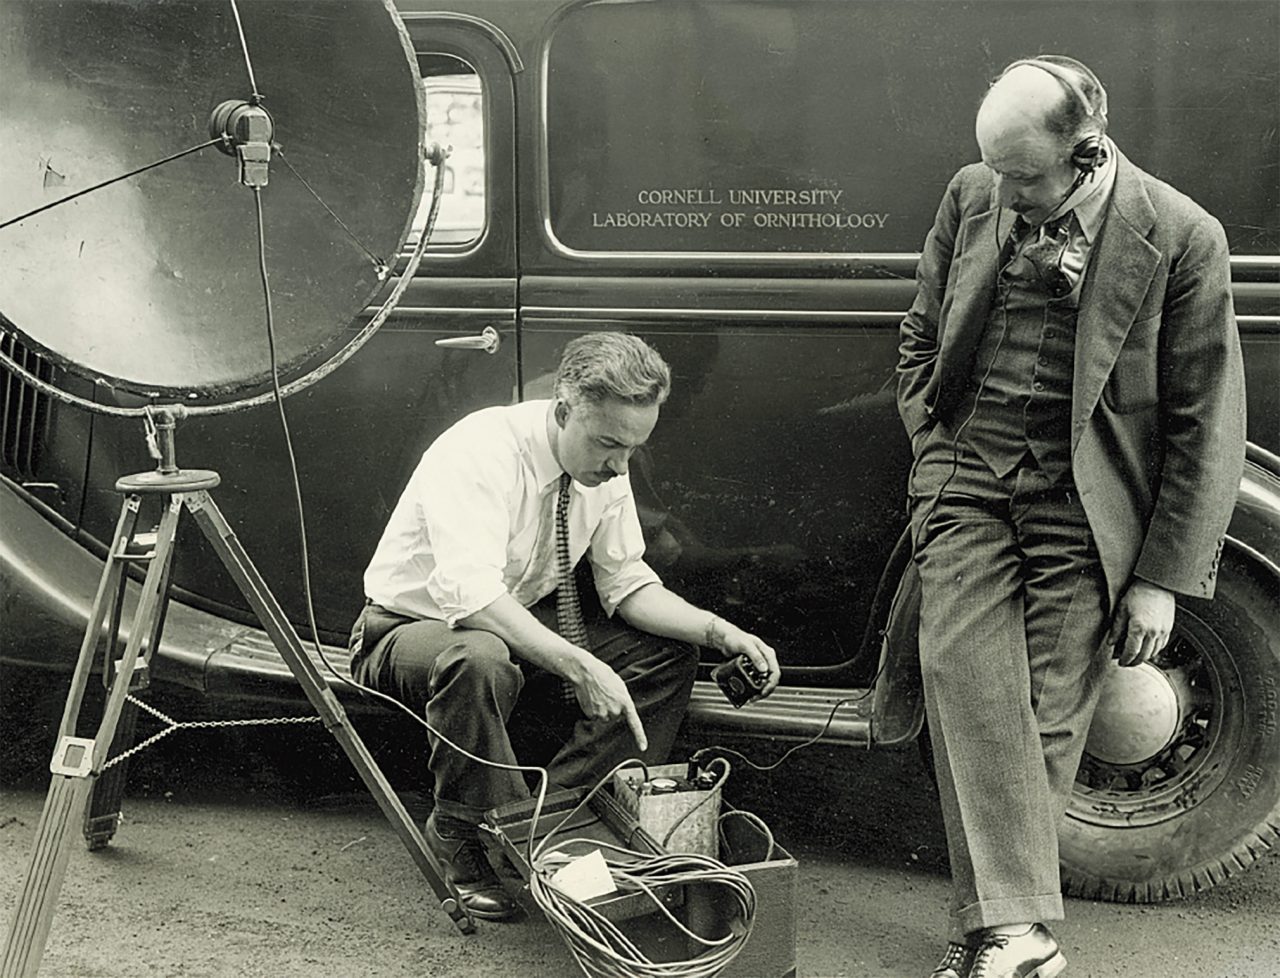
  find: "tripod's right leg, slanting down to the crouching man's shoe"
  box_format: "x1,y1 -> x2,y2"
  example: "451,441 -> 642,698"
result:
183,492 -> 475,933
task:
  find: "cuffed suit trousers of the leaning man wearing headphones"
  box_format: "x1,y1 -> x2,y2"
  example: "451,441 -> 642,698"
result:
911,426 -> 1108,938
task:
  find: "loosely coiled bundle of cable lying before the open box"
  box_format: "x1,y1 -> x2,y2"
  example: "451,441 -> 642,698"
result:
529,838 -> 755,978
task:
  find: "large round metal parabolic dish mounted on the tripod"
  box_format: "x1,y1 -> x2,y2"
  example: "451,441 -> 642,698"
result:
0,0 -> 422,399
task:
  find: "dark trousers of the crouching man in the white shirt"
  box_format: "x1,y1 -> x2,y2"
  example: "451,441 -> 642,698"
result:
351,595 -> 698,823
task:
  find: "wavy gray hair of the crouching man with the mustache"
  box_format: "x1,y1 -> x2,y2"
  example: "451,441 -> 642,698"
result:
556,333 -> 671,407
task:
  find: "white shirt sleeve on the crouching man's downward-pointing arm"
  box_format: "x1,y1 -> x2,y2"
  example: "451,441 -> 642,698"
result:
415,442 -> 515,626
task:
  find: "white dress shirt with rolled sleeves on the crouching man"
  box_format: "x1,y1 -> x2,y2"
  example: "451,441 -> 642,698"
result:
365,401 -> 659,626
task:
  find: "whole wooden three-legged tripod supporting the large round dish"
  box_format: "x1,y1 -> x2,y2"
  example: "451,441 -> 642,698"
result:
0,406 -> 475,978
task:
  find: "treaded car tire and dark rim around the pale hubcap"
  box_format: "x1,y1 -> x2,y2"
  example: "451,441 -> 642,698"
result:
1059,552 -> 1280,902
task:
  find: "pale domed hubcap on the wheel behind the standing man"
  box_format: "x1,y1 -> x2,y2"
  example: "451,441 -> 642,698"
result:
1084,662 -> 1181,764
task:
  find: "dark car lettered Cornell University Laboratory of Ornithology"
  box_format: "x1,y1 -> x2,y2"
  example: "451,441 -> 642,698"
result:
0,0 -> 1280,901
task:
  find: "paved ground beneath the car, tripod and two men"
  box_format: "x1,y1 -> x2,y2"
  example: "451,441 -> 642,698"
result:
0,676 -> 1280,978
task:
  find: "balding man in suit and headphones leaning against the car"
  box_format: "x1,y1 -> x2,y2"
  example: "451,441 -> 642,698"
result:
899,55 -> 1244,978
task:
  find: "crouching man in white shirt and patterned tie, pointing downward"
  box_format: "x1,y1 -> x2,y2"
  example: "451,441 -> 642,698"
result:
352,333 -> 780,920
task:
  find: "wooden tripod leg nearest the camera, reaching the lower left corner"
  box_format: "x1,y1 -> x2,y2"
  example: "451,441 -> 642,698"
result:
0,495 -> 179,978
